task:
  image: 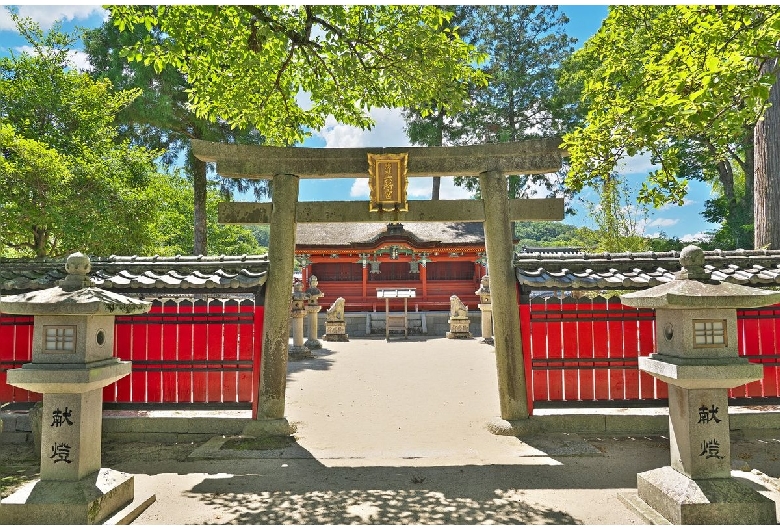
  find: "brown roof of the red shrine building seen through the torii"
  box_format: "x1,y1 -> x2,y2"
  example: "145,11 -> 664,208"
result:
295,222 -> 485,248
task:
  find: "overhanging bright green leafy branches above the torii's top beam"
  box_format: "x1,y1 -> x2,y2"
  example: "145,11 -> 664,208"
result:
109,5 -> 483,145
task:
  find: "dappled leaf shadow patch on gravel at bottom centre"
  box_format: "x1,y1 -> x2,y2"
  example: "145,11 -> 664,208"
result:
188,464 -> 581,525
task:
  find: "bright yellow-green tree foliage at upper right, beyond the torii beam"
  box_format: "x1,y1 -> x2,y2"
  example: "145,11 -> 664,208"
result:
564,5 -> 780,250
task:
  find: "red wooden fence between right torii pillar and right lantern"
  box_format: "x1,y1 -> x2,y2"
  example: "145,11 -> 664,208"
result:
521,297 -> 667,410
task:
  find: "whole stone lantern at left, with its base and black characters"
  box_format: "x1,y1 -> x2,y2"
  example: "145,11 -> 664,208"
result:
0,253 -> 151,524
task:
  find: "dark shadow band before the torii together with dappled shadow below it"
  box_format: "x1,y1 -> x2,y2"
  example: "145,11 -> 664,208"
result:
100,434 -> 668,525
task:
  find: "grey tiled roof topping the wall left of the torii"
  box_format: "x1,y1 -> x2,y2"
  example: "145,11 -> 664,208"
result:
0,256 -> 268,295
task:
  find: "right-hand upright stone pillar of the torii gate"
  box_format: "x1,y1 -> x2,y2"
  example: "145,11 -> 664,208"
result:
479,171 -> 529,420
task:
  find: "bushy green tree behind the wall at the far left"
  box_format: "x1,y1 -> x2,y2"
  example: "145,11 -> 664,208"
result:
0,19 -> 162,257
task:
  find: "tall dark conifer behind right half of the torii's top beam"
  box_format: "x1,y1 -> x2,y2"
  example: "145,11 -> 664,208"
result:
405,5 -> 575,204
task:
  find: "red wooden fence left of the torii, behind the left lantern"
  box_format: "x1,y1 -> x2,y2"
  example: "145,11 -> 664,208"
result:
0,300 -> 263,404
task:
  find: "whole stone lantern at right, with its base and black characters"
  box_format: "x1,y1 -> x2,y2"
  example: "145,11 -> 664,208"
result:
621,246 -> 780,525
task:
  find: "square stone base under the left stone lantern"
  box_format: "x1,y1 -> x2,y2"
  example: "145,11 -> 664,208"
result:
0,468 -> 140,525
